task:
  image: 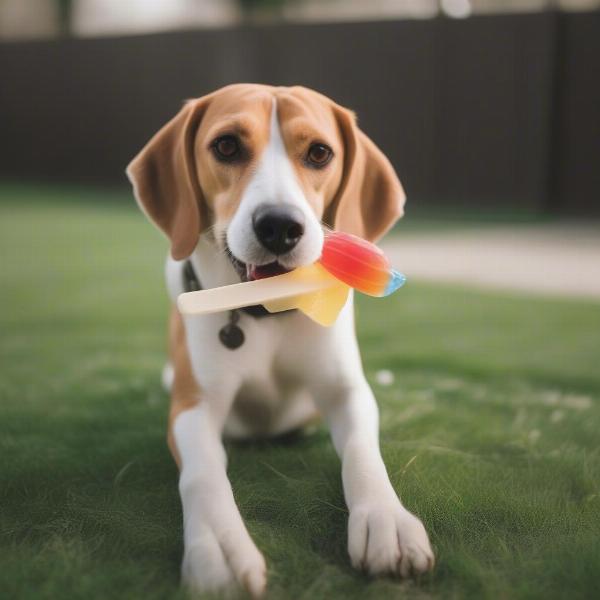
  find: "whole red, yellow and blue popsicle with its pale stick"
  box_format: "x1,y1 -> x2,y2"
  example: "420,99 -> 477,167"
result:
177,231 -> 405,326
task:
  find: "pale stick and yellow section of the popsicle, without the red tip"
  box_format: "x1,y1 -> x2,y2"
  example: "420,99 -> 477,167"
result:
177,263 -> 350,326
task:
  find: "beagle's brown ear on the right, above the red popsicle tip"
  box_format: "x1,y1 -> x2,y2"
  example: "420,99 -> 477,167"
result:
325,104 -> 406,242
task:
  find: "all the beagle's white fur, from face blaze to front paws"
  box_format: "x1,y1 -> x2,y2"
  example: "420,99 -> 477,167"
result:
167,99 -> 433,596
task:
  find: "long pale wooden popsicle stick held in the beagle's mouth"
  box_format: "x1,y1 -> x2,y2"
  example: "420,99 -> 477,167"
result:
177,264 -> 337,315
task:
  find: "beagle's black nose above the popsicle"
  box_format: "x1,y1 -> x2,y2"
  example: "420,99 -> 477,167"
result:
252,204 -> 304,255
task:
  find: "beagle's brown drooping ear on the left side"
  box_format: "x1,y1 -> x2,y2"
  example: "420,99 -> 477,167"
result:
127,96 -> 209,260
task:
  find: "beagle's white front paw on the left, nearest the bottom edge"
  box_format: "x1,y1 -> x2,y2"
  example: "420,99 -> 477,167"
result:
181,528 -> 267,598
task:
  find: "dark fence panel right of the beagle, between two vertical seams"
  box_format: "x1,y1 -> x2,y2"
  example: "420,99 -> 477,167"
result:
434,14 -> 554,208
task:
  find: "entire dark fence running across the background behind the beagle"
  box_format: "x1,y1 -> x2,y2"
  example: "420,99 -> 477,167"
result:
0,14 -> 600,211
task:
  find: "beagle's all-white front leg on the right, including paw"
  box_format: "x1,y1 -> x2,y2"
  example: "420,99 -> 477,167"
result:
321,376 -> 434,577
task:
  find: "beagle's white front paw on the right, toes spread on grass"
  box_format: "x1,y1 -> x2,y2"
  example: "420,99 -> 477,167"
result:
348,499 -> 434,577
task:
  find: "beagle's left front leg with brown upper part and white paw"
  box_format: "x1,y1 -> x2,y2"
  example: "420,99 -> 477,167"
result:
169,313 -> 266,597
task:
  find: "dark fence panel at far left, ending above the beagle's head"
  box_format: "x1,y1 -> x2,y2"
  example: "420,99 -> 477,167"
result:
0,31 -> 253,182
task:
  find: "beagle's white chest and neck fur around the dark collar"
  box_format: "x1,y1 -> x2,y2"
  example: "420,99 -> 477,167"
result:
166,251 -> 360,438
